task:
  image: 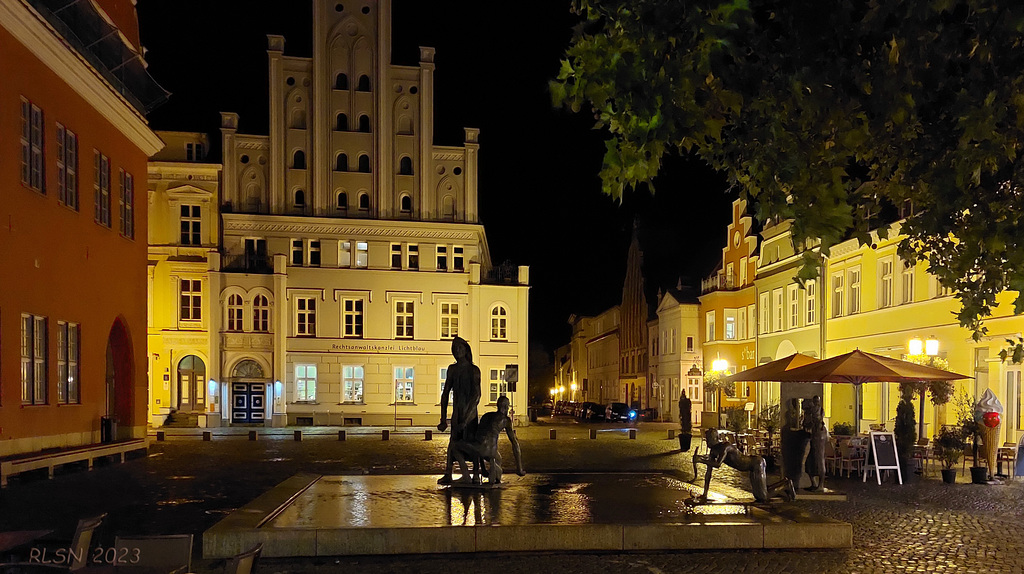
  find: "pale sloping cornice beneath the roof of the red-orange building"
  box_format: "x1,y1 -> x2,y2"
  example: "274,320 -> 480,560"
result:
0,0 -> 164,157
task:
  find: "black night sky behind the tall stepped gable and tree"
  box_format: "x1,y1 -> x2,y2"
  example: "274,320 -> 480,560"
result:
137,0 -> 731,366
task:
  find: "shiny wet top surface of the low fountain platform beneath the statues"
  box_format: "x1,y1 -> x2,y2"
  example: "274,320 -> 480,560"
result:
267,473 -> 755,529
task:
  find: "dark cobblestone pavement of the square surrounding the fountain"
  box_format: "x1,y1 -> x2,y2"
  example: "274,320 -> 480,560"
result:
0,424 -> 1024,574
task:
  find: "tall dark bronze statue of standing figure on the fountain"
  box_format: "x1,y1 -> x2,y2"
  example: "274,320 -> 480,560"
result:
437,337 -> 480,484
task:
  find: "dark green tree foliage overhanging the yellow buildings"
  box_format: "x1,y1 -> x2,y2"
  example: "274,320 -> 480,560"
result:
551,0 -> 1024,338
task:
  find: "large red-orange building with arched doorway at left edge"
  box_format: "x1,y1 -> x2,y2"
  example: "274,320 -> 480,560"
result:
0,0 -> 166,456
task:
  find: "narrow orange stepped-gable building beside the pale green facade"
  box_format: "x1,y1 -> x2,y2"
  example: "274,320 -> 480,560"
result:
699,200 -> 758,420
